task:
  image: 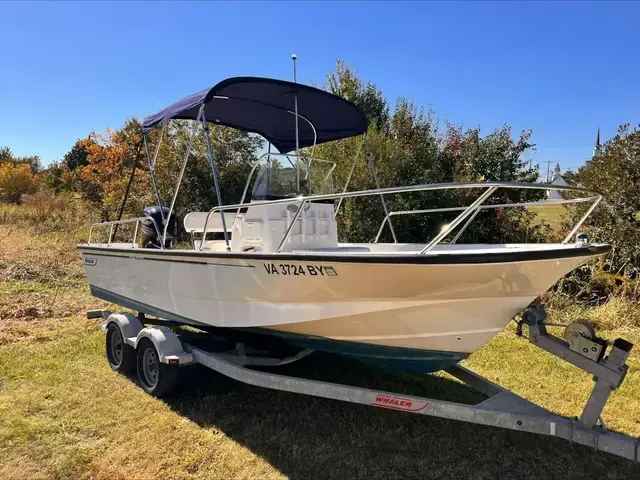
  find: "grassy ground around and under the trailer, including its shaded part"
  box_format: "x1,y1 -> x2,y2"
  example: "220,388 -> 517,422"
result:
0,218 -> 640,480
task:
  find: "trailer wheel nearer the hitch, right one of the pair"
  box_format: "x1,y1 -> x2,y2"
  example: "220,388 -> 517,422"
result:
136,338 -> 178,398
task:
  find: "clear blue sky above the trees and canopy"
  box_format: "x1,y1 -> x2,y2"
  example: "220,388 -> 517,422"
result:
0,2 -> 640,173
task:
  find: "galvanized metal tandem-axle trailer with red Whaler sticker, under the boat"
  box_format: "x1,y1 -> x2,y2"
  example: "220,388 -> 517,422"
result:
87,308 -> 640,462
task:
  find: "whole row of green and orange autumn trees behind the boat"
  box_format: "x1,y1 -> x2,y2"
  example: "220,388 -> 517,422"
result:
0,61 -> 640,290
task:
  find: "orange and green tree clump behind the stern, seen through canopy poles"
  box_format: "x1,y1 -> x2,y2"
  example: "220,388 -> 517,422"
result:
74,119 -> 262,229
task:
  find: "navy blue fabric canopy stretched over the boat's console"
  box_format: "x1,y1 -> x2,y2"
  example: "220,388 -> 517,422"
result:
142,77 -> 367,153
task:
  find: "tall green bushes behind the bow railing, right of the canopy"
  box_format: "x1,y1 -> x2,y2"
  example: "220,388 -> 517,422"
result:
316,61 -> 545,246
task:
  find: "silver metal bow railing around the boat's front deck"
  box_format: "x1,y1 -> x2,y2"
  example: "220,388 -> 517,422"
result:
200,182 -> 602,255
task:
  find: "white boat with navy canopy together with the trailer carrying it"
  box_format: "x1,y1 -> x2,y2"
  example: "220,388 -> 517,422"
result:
78,71 -> 640,461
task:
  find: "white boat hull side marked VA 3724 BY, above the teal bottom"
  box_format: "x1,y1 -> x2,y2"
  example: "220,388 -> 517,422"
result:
80,245 -> 604,364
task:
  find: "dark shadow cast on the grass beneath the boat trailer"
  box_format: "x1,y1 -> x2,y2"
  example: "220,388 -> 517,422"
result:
167,353 -> 640,480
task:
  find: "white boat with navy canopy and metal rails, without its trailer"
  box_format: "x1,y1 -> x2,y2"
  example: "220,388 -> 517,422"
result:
78,77 -> 610,373
